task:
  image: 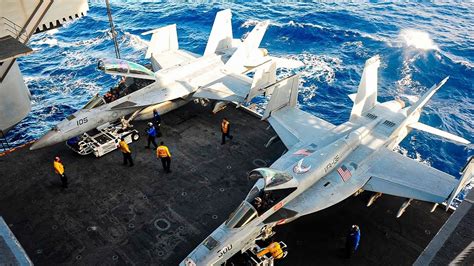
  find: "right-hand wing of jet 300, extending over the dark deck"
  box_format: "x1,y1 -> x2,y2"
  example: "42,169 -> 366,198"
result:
363,148 -> 459,203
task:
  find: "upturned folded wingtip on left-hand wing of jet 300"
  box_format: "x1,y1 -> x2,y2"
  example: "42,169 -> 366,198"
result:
262,74 -> 299,120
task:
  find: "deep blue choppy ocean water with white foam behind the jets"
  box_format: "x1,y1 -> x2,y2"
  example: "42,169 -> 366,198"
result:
8,1 -> 474,200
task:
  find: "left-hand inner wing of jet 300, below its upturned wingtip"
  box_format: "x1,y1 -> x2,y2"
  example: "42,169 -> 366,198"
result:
268,106 -> 336,149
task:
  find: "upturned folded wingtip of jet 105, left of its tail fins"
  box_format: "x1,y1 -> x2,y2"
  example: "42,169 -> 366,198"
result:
142,24 -> 179,58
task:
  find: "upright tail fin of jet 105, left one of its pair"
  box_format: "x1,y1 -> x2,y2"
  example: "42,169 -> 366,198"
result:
204,9 -> 233,55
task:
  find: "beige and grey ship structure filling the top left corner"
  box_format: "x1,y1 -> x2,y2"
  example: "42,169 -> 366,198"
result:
0,0 -> 89,133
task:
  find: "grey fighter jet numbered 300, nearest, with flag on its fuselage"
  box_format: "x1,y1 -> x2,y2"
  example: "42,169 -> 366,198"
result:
181,56 -> 474,265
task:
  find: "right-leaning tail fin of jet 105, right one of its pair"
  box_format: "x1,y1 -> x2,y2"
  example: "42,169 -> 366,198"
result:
225,21 -> 269,73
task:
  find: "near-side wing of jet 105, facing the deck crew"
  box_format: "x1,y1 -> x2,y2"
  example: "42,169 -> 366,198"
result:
193,74 -> 252,102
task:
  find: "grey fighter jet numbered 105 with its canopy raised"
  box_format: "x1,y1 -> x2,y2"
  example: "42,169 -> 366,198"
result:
31,9 -> 300,150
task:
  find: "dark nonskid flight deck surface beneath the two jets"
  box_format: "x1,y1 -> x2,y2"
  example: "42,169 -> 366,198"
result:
0,103 -> 448,265
